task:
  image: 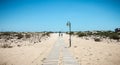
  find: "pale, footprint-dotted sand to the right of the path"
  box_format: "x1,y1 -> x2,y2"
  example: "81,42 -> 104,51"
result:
64,35 -> 120,65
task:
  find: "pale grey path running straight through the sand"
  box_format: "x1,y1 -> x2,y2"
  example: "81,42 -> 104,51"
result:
42,38 -> 79,65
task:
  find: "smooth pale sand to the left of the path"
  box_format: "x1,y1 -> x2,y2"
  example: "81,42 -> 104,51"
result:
0,34 -> 57,65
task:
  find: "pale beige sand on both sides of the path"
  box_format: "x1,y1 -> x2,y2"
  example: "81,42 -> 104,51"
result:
0,34 -> 120,65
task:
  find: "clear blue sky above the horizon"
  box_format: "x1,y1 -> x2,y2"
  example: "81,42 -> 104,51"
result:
0,0 -> 120,32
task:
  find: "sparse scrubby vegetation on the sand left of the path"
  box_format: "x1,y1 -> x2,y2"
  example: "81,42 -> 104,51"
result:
0,32 -> 52,48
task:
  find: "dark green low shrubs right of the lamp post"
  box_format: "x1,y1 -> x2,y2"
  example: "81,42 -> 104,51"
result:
67,31 -> 120,42
